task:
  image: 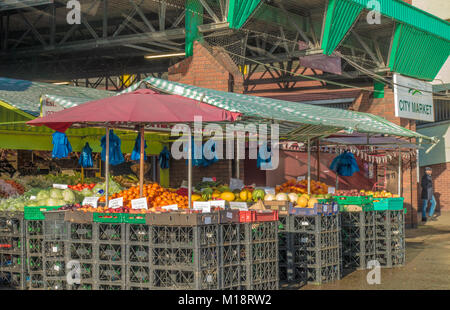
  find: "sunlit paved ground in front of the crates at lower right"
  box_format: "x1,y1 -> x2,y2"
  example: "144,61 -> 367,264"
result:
302,212 -> 450,290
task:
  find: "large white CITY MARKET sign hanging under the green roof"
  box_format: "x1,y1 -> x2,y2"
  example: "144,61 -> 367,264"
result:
394,73 -> 434,122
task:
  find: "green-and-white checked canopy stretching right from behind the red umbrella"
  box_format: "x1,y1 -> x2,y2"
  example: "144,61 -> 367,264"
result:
116,77 -> 434,142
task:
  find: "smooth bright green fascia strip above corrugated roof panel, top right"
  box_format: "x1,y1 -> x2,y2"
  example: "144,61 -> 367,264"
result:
350,0 -> 450,41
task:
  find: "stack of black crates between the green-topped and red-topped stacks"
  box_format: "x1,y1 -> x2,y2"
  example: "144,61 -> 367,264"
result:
147,213 -> 220,290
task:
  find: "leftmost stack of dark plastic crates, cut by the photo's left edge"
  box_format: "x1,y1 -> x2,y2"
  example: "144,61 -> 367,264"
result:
0,212 -> 26,289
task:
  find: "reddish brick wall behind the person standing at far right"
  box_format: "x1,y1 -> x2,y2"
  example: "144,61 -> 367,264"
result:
418,162 -> 450,212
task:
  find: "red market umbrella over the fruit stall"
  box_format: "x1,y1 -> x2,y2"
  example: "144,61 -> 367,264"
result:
27,89 -> 240,132
